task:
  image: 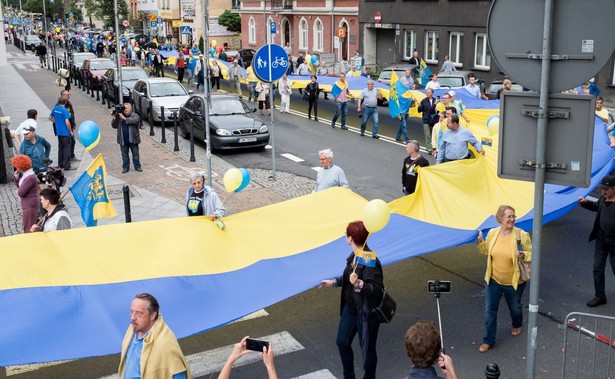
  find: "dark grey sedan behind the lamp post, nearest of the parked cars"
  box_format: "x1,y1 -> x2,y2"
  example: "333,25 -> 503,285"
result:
179,93 -> 269,150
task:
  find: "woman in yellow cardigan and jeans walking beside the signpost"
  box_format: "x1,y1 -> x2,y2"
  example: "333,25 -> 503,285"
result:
476,205 -> 532,353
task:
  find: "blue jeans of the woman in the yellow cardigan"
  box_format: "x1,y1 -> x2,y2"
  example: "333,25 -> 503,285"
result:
483,279 -> 526,345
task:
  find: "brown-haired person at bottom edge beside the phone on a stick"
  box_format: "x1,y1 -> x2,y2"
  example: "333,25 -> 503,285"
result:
405,320 -> 458,379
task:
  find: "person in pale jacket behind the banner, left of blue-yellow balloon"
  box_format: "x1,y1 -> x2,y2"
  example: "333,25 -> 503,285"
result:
186,174 -> 226,221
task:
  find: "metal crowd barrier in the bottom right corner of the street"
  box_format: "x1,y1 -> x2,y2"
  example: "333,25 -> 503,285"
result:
561,312 -> 615,379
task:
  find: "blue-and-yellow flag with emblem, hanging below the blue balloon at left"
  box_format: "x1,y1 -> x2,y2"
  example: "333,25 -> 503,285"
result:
69,154 -> 117,227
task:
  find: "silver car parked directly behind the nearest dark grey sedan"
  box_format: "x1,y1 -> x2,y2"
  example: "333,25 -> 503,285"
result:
131,78 -> 192,122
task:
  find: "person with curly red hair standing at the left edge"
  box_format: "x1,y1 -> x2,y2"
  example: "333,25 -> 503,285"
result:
11,154 -> 40,233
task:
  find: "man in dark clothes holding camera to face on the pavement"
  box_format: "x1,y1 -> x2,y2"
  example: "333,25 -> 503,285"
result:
111,103 -> 143,174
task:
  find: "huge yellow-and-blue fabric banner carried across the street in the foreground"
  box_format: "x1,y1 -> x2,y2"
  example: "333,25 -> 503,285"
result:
0,91 -> 615,366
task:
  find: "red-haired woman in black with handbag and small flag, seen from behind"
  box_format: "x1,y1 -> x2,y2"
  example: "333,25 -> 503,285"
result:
319,221 -> 384,379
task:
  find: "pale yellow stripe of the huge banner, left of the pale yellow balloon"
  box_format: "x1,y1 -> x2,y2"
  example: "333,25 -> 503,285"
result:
0,188 -> 367,289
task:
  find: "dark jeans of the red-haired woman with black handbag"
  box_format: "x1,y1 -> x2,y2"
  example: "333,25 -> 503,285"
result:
336,306 -> 380,379
